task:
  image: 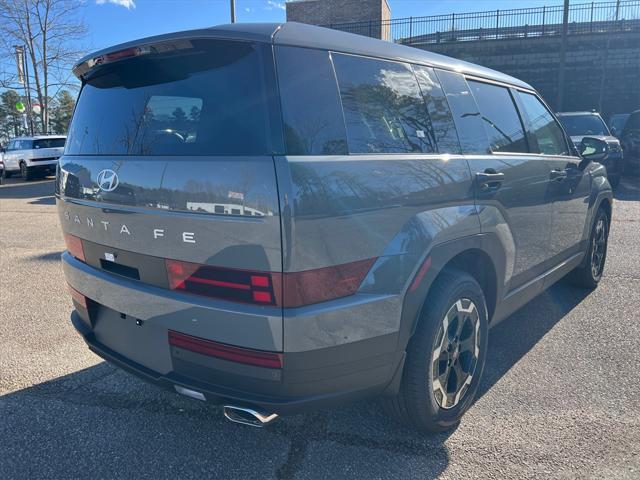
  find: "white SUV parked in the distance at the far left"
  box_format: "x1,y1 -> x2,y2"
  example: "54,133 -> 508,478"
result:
2,135 -> 65,180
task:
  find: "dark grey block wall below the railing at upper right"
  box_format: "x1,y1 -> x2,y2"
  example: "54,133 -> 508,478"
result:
421,31 -> 640,117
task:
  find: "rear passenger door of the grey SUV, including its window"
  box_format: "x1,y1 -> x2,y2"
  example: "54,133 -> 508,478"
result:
438,71 -> 551,288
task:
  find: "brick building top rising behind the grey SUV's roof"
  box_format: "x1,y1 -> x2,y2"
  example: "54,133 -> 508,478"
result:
286,0 -> 391,40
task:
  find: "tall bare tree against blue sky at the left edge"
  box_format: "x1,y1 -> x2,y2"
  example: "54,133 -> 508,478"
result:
0,0 -> 86,132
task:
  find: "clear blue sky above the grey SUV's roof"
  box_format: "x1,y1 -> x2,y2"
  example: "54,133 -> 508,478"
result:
82,0 -> 564,50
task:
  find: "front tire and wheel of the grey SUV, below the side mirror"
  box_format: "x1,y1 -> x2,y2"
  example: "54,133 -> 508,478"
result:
567,207 -> 609,290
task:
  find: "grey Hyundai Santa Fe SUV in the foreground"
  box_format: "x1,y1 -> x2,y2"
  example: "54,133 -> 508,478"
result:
56,23 -> 612,431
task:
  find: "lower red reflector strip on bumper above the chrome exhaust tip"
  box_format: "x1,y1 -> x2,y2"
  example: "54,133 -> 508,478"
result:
169,330 -> 282,368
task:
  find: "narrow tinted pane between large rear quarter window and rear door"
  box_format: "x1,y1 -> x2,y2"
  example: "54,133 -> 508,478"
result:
413,65 -> 460,153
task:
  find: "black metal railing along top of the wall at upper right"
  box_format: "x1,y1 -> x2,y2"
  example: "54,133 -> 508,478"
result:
325,0 -> 640,45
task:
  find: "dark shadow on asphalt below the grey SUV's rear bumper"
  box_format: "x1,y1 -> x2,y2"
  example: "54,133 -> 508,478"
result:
0,362 -> 449,479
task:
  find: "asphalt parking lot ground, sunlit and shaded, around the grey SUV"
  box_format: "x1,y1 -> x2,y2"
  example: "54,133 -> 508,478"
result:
0,178 -> 640,479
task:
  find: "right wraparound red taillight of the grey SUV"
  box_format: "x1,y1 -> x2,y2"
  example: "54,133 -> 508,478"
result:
166,258 -> 376,308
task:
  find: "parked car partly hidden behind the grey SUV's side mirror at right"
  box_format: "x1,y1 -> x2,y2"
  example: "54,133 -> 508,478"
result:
557,112 -> 624,188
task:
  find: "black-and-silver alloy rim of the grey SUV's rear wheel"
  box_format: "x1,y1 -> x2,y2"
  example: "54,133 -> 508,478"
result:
431,298 -> 480,409
